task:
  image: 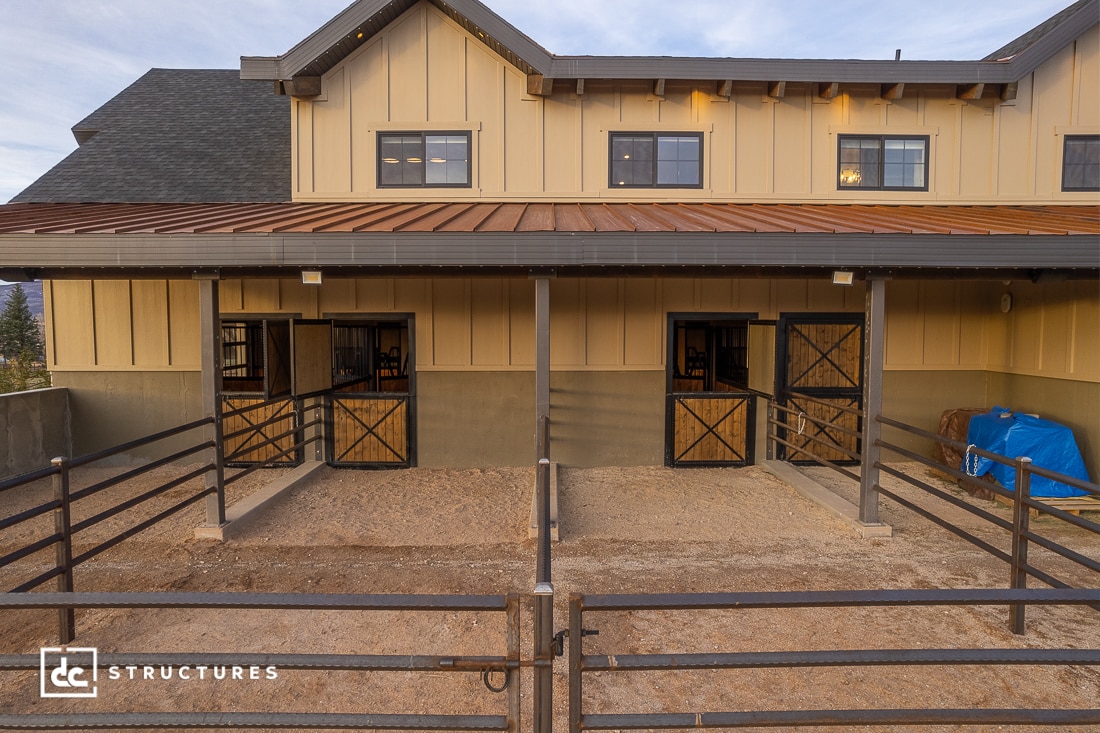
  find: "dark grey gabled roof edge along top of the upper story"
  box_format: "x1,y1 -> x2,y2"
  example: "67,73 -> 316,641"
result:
241,0 -> 1100,84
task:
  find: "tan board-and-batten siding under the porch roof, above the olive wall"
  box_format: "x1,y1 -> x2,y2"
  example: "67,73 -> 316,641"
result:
44,277 -> 1100,382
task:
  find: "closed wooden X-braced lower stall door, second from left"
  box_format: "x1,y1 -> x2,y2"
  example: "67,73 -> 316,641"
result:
327,392 -> 416,468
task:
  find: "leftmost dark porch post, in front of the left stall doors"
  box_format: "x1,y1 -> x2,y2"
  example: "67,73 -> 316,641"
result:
195,274 -> 226,527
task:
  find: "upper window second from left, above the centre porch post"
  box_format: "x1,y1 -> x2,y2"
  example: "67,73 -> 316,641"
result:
608,132 -> 703,188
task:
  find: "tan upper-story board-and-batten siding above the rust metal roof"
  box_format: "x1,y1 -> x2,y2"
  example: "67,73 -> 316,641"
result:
292,2 -> 1100,204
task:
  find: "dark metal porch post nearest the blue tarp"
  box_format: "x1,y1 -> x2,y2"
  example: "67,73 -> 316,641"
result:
859,270 -> 887,524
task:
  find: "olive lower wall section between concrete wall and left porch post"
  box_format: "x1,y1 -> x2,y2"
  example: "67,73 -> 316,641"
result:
53,371 -> 202,461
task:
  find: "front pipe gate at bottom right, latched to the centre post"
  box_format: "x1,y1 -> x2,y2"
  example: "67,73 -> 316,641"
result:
568,589 -> 1100,733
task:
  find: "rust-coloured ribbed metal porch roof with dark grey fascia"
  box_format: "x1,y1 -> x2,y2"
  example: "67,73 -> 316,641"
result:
0,204 -> 1100,280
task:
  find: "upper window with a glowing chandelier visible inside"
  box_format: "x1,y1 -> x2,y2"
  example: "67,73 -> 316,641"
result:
837,135 -> 928,190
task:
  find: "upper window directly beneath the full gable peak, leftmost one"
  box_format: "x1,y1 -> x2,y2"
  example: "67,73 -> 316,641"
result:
378,132 -> 470,188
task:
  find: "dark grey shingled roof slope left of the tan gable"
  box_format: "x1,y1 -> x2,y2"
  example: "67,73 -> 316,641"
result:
12,68 -> 290,203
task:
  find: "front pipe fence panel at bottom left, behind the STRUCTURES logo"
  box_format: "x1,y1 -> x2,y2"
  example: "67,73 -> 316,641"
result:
0,592 -> 521,733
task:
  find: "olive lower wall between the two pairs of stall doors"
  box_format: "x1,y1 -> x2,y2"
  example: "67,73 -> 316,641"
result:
417,371 -> 664,468
